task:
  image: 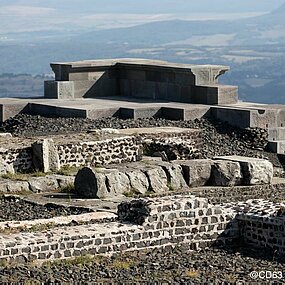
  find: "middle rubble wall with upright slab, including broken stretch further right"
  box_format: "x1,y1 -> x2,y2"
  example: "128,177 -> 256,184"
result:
0,130 -> 202,172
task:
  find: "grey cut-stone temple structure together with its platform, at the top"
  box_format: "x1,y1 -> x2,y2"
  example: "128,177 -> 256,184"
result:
0,56 -> 285,153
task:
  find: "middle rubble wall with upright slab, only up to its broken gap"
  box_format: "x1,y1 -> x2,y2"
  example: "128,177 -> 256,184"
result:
0,136 -> 142,173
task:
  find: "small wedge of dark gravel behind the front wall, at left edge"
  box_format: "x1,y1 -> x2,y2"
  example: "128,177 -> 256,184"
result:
0,196 -> 90,222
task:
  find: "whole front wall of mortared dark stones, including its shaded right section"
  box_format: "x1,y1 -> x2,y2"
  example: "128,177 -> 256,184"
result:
0,195 -> 285,262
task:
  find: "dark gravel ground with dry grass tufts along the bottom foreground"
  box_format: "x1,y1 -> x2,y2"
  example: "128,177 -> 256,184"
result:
0,243 -> 285,284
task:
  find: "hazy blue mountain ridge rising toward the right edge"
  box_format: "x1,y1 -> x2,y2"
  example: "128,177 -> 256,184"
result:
72,4 -> 285,45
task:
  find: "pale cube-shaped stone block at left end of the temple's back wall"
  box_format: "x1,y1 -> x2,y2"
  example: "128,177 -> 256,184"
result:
44,80 -> 74,99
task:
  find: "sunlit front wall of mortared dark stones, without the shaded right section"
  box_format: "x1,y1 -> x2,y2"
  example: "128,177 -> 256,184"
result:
0,196 -> 237,261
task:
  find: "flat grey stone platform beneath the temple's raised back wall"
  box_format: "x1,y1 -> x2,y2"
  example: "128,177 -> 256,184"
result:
0,96 -> 285,129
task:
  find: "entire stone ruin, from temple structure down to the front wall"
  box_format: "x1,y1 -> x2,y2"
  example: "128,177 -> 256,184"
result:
0,59 -> 285,266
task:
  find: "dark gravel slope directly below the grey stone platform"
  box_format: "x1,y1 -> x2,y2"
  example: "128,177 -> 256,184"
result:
0,114 -> 282,167
